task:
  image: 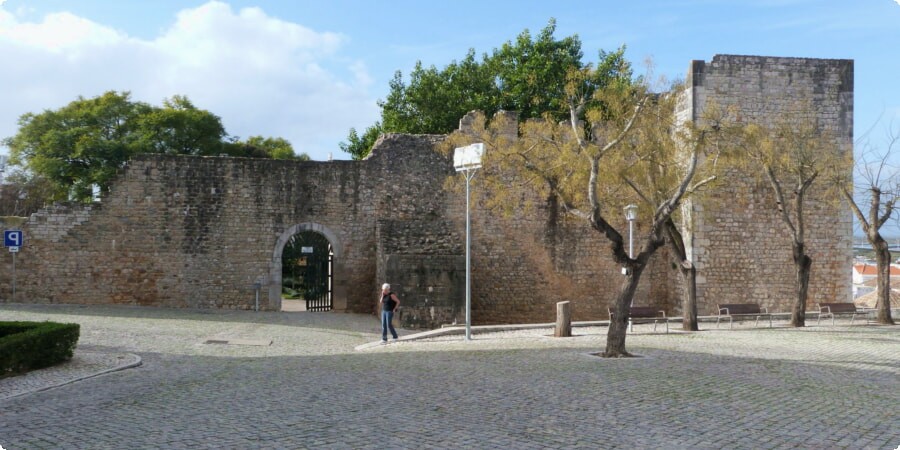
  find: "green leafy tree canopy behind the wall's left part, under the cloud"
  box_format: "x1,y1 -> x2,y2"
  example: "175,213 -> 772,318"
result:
3,91 -> 309,201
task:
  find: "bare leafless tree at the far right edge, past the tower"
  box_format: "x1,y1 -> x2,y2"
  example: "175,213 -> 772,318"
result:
835,127 -> 900,325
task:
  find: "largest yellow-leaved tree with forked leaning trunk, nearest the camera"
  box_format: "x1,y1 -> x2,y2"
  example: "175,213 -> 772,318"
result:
445,64 -> 714,357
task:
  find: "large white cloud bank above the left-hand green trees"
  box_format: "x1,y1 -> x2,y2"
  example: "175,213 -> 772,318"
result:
0,1 -> 377,159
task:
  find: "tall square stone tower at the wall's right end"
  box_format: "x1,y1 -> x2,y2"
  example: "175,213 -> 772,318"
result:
678,55 -> 853,314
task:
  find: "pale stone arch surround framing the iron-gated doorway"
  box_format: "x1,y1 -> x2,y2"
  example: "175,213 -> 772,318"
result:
268,222 -> 347,311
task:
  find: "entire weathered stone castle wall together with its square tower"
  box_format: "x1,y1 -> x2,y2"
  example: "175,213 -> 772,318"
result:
0,56 -> 852,327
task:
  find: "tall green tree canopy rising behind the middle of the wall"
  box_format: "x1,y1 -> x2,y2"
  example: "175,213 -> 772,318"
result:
340,19 -> 632,159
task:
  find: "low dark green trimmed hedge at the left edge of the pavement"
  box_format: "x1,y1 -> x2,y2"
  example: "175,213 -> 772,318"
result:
0,322 -> 81,378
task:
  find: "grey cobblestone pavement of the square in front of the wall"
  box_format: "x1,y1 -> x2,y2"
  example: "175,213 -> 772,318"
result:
0,305 -> 900,450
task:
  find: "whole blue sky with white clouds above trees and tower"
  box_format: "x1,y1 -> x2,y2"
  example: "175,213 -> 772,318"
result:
0,0 -> 900,160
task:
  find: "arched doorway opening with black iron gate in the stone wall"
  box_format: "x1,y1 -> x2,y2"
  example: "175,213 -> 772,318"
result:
282,231 -> 334,311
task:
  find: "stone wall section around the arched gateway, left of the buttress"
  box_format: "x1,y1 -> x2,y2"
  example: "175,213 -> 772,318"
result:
0,155 -> 375,310
